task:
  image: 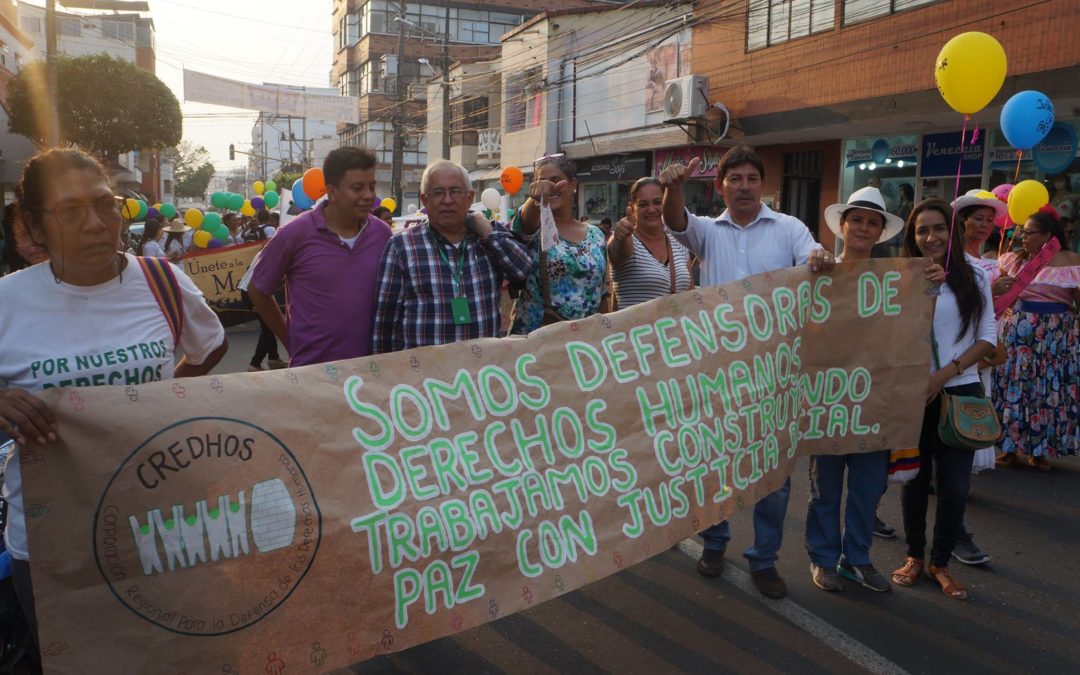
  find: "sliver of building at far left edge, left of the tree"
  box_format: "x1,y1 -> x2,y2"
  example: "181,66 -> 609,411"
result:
0,0 -> 37,207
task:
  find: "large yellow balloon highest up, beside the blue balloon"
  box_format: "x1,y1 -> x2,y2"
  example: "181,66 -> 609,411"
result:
934,31 -> 1007,114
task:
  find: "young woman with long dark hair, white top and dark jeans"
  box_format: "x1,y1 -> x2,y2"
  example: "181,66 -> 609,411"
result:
892,199 -> 997,599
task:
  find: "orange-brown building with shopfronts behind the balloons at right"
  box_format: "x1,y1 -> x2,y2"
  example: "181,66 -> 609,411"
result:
691,0 -> 1080,246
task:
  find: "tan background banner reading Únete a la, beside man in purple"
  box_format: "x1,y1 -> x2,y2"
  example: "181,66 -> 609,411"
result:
180,241 -> 266,326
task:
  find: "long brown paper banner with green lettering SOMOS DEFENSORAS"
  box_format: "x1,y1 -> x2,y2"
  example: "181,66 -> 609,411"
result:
22,260 -> 930,674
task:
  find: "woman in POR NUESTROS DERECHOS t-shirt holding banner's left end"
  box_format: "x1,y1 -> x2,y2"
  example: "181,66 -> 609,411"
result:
0,149 -> 227,656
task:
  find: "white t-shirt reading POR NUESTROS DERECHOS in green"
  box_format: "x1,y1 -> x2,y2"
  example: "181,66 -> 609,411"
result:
0,254 -> 225,561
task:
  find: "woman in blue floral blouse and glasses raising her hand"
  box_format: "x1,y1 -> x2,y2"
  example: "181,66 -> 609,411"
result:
510,156 -> 609,335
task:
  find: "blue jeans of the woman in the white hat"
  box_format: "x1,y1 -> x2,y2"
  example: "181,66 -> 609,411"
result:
807,450 -> 889,569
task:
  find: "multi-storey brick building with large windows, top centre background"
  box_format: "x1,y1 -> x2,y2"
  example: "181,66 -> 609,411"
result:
332,0 -> 598,204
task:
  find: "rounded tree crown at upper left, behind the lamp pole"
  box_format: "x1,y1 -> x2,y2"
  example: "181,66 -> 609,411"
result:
8,54 -> 184,160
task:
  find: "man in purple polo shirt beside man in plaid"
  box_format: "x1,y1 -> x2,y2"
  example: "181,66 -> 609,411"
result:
247,148 -> 390,367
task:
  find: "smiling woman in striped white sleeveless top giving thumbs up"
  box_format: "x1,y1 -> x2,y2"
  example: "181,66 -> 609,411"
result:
607,178 -> 692,309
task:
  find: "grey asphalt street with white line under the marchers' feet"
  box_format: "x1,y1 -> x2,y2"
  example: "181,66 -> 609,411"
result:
218,324 -> 1080,673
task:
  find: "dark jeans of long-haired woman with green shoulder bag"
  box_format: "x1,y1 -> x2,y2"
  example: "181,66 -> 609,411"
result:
900,383 -> 983,567
